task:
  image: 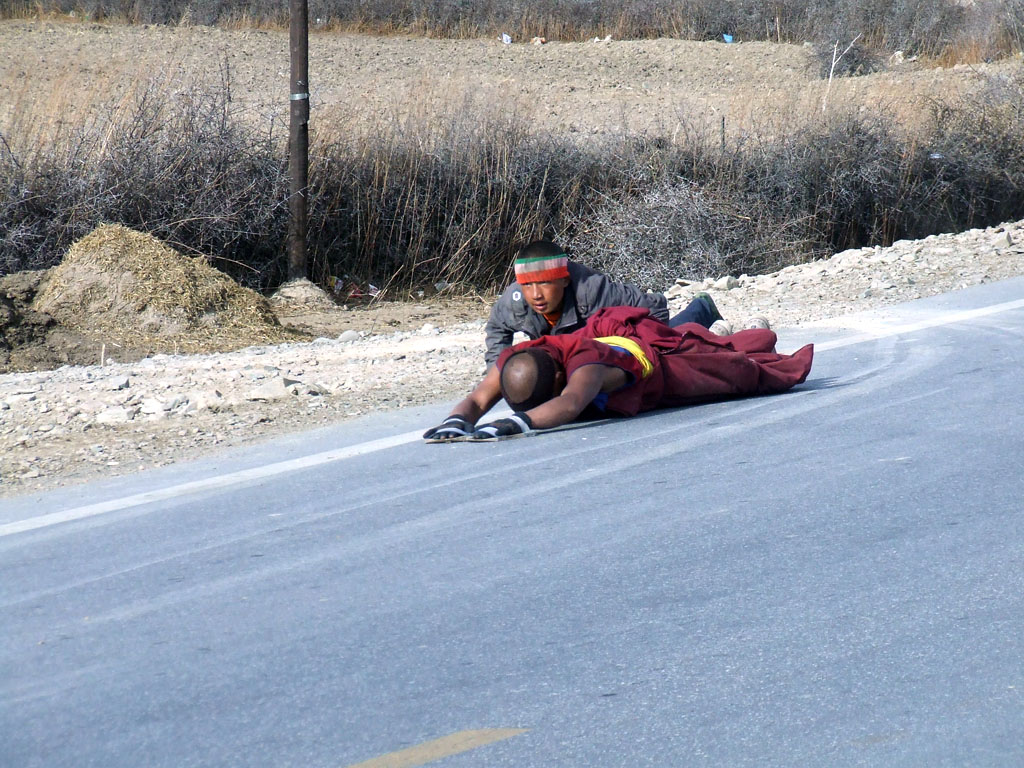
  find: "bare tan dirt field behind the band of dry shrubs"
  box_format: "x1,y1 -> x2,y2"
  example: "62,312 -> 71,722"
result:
0,22 -> 1020,143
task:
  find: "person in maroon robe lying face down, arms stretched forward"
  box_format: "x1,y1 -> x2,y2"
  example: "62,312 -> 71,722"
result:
423,306 -> 814,441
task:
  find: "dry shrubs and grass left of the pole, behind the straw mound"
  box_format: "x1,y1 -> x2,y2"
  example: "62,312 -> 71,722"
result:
0,68 -> 288,285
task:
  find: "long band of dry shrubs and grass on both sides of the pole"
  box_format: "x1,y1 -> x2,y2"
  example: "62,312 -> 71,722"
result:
6,67 -> 1024,293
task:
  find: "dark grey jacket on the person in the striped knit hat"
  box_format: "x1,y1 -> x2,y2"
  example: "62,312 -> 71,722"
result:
484,261 -> 669,366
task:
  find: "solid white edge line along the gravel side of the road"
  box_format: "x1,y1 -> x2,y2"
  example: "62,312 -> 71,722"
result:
0,290 -> 1024,537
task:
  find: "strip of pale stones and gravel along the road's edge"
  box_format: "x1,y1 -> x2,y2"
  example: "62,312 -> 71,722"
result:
0,221 -> 1024,496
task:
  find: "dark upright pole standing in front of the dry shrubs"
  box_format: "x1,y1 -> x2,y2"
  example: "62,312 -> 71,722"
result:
288,0 -> 309,280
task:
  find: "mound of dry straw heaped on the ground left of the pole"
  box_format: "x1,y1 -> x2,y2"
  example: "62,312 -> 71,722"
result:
33,224 -> 304,352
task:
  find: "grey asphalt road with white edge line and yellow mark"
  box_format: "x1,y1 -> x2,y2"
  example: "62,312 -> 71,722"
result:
0,280 -> 1024,768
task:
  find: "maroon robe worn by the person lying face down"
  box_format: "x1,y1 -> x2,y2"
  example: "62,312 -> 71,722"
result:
498,307 -> 814,416
